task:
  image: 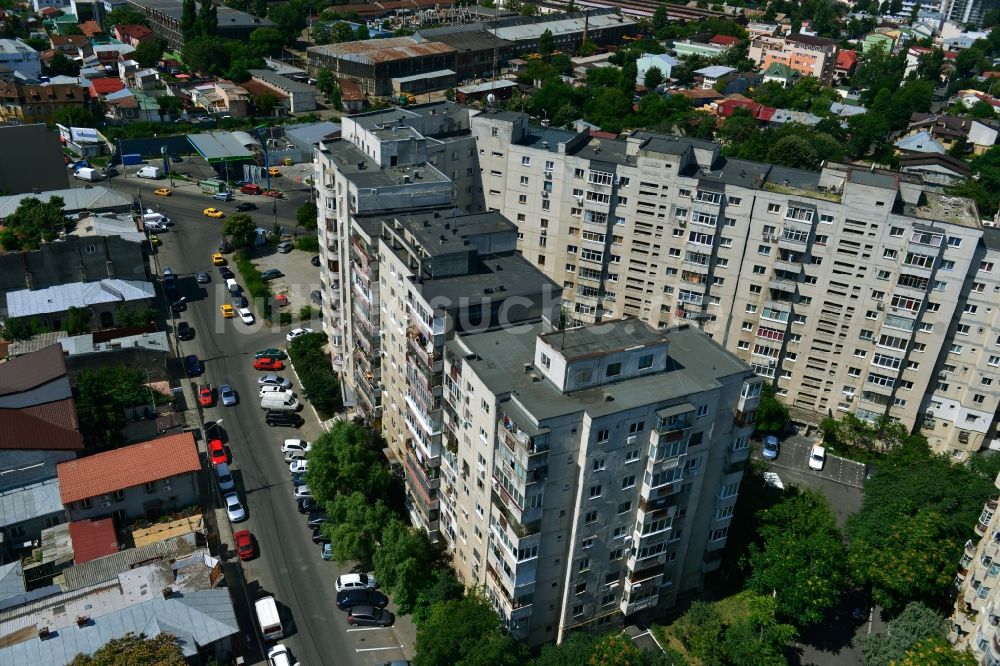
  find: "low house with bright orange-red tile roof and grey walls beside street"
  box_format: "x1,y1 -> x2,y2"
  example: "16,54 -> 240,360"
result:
56,432 -> 201,525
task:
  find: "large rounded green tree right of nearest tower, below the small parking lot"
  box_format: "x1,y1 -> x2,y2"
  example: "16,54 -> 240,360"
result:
747,491 -> 849,627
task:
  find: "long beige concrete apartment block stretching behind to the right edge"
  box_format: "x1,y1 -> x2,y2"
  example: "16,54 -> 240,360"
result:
471,111 -> 1000,459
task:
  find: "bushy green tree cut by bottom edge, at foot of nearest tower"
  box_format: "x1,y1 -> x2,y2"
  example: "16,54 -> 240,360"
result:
413,591 -> 527,666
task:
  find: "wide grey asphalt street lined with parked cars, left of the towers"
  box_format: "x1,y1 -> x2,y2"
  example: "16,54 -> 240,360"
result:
86,170 -> 414,666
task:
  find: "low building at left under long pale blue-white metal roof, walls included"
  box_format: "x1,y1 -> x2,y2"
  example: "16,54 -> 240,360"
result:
7,278 -> 156,329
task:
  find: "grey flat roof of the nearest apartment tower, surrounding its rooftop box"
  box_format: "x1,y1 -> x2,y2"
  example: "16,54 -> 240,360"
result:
448,320 -> 750,425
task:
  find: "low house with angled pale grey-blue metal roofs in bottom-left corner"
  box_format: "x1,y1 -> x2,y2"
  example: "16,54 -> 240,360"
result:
0,549 -> 240,666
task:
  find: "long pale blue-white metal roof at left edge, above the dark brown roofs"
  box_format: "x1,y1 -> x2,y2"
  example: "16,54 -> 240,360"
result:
7,278 -> 156,317
